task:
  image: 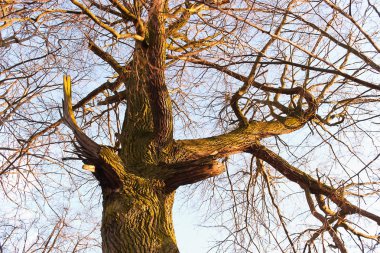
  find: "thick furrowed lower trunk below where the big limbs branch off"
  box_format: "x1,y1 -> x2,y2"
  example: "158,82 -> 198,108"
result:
101,176 -> 179,253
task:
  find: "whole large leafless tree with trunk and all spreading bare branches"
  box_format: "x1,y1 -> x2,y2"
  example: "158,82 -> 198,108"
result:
0,0 -> 380,252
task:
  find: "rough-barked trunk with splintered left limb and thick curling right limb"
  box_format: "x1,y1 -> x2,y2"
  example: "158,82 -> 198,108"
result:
60,0 -> 326,253
